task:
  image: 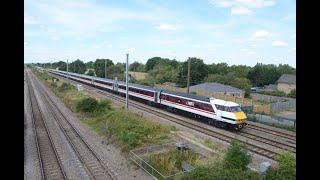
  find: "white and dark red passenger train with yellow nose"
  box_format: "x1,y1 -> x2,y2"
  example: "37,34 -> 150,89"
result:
48,69 -> 247,130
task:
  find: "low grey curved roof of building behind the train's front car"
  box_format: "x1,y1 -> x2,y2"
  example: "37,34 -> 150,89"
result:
190,83 -> 244,93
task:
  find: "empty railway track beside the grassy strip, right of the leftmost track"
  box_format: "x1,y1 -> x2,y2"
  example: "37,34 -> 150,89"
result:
28,70 -> 116,179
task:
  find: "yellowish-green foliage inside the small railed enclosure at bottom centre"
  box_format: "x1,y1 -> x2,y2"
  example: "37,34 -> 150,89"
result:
146,148 -> 200,175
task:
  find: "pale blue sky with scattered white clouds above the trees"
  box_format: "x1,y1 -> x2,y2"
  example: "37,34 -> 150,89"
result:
24,0 -> 296,67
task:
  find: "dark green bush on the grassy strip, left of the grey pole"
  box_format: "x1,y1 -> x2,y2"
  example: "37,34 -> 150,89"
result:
76,97 -> 111,114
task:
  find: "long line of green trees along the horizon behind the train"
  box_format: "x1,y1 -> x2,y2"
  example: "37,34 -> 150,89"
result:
36,57 -> 296,95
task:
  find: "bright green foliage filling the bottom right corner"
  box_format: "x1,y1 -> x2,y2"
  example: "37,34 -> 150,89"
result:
266,151 -> 296,180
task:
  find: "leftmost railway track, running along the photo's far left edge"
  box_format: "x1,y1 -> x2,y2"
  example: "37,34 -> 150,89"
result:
28,72 -> 68,180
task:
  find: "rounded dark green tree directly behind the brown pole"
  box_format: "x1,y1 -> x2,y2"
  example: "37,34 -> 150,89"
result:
177,57 -> 208,87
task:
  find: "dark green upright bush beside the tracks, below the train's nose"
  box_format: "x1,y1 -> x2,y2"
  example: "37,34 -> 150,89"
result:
224,140 -> 251,170
